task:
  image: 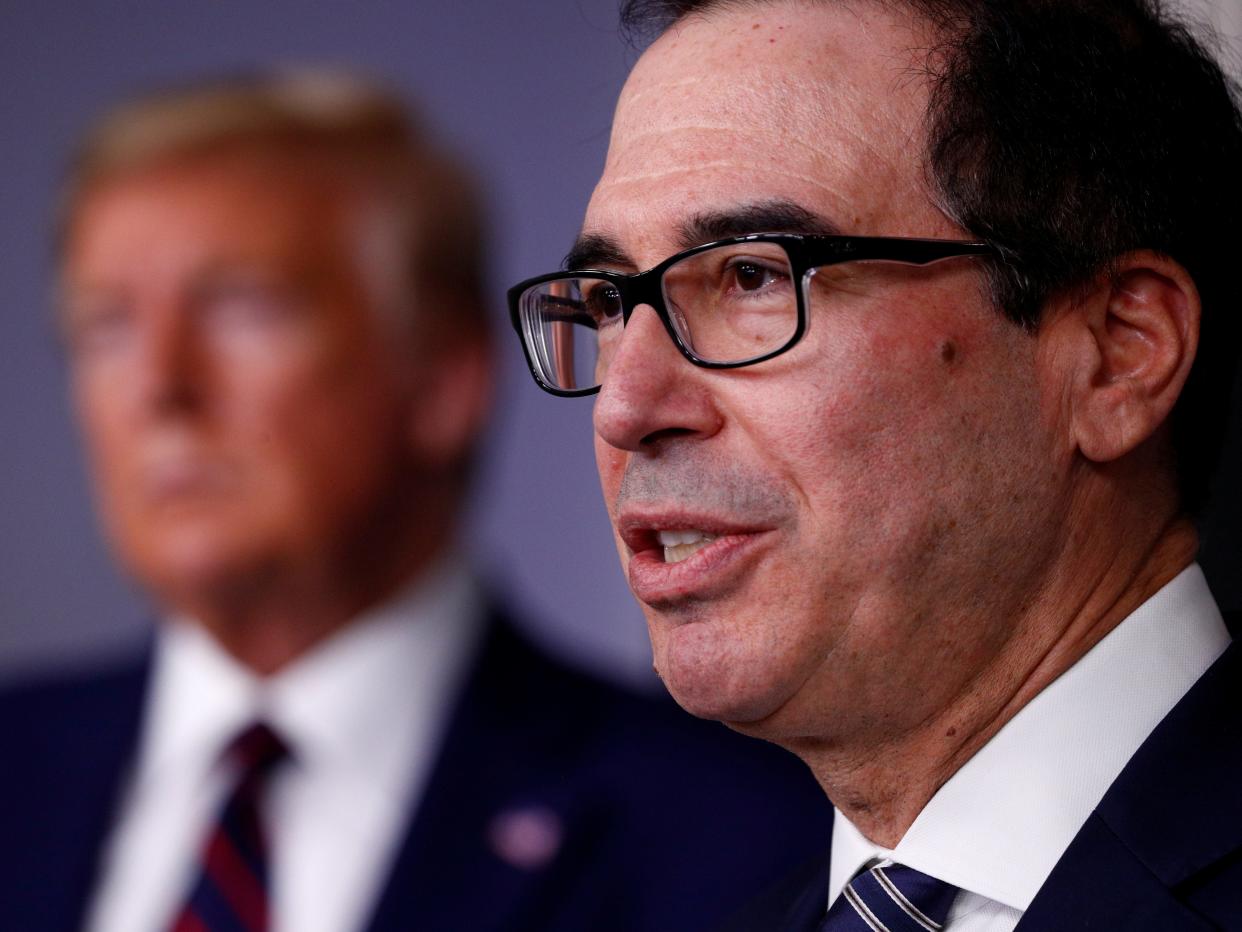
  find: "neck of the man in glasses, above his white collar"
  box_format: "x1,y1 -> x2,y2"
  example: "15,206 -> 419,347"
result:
791,518 -> 1197,847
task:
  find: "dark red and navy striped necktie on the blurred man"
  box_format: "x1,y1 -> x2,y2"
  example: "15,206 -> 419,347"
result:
171,724 -> 288,932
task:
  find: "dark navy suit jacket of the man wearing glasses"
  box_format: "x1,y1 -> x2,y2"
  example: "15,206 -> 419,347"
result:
729,642 -> 1242,932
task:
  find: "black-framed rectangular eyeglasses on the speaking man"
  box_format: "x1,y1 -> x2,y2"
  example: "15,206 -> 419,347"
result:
509,234 -> 999,396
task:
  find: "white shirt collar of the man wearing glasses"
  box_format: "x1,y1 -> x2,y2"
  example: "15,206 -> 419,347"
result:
828,565 -> 1230,932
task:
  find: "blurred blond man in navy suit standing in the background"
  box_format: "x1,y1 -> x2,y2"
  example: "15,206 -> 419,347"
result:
0,73 -> 827,932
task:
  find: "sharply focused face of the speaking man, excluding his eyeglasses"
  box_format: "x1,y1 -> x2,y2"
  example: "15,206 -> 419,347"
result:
580,2 -> 1068,738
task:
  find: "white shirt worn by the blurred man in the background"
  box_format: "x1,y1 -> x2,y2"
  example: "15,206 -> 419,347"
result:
86,562 -> 483,932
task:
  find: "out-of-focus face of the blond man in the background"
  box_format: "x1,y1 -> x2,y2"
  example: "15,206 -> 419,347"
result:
63,157 -> 427,608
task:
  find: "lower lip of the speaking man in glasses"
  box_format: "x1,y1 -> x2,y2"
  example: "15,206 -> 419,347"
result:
630,532 -> 768,608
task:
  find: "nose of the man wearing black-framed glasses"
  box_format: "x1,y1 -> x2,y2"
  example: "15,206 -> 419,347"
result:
595,304 -> 720,451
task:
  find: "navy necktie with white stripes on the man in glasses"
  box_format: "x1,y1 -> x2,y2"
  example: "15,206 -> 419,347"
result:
818,864 -> 958,932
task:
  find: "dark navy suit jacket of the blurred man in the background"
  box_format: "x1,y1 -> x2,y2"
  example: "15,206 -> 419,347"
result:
0,615 -> 831,932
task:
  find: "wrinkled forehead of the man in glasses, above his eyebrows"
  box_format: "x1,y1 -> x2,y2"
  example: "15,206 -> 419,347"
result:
586,2 -> 944,255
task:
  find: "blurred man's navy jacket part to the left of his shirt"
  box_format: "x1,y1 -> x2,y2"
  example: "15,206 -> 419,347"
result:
0,652 -> 150,932
